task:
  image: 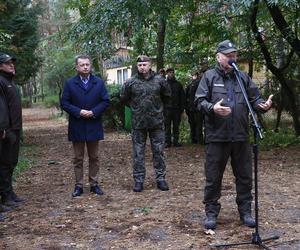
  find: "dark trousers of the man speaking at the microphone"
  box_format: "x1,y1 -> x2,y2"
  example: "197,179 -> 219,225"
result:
204,142 -> 252,216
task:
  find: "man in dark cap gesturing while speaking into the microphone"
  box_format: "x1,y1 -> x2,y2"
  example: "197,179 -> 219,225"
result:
195,40 -> 272,229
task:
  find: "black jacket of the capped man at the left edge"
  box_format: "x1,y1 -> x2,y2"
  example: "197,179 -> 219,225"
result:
0,72 -> 22,130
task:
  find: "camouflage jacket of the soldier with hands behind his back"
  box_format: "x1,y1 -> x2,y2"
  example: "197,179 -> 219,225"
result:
120,72 -> 171,129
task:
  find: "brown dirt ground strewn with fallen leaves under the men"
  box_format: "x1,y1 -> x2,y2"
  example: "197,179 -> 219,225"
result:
0,106 -> 300,250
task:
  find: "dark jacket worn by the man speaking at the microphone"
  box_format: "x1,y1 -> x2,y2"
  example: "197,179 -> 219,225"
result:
195,65 -> 264,143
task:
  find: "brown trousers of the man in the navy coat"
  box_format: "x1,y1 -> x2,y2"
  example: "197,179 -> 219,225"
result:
73,141 -> 100,187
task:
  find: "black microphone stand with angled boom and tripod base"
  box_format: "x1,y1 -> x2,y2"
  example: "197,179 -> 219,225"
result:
211,65 -> 279,250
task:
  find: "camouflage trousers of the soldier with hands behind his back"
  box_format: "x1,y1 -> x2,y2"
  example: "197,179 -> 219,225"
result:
132,128 -> 166,182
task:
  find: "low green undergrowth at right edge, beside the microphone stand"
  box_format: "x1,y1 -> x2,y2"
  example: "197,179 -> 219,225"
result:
259,129 -> 300,150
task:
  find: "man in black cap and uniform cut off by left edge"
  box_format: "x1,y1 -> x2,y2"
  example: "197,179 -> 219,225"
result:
0,53 -> 23,207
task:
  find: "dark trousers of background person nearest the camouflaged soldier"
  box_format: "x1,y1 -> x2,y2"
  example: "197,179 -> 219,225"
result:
164,109 -> 181,144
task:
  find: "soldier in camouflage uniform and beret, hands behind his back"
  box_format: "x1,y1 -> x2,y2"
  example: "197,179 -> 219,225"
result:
121,56 -> 171,192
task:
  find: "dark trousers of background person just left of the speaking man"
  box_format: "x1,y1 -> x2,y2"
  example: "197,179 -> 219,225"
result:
186,110 -> 204,144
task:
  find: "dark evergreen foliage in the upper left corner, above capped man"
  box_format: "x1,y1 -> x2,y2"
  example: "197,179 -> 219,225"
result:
0,0 -> 41,84
